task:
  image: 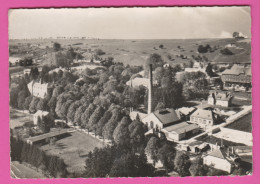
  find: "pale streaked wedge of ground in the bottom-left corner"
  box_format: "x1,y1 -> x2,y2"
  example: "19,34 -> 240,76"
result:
10,161 -> 46,179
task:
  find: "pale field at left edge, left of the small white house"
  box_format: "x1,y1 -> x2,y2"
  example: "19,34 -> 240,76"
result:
9,109 -> 33,129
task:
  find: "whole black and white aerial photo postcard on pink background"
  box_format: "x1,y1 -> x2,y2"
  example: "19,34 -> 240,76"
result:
8,6 -> 253,179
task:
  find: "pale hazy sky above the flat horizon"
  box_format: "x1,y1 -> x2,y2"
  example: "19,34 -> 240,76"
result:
9,6 -> 251,39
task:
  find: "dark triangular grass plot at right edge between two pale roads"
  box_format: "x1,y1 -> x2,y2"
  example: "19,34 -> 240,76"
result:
225,113 -> 252,132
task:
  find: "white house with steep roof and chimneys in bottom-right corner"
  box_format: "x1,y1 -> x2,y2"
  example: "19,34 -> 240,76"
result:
203,147 -> 239,173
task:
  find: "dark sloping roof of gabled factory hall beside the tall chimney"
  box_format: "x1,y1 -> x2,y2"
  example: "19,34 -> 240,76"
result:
153,109 -> 180,125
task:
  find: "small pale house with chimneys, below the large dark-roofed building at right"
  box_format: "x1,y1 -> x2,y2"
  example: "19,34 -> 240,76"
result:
208,92 -> 232,107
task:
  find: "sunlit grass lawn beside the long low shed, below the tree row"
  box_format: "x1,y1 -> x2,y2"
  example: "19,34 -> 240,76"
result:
41,131 -> 105,173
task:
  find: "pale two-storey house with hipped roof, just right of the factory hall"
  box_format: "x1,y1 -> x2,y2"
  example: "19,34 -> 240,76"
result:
190,108 -> 217,130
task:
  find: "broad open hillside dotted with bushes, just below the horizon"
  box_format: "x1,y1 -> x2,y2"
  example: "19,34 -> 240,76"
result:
9,38 -> 251,65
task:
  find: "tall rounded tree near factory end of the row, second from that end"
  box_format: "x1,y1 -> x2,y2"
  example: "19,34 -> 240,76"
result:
113,116 -> 130,145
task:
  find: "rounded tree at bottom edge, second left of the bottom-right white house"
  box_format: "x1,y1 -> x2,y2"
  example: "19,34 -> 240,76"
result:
174,152 -> 191,177
